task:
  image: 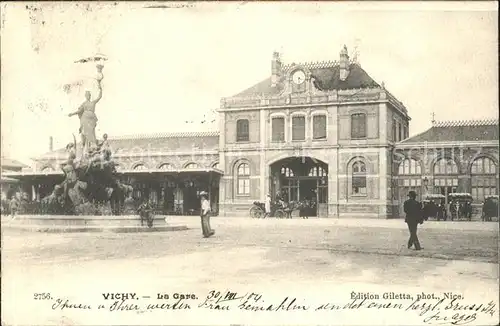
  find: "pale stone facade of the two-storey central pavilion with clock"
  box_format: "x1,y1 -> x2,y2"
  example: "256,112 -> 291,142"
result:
219,47 -> 410,218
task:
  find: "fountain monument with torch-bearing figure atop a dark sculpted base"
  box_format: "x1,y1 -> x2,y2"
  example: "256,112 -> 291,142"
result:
42,64 -> 132,215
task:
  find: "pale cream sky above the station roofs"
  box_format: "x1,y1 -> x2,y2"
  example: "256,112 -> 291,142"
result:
1,2 -> 498,163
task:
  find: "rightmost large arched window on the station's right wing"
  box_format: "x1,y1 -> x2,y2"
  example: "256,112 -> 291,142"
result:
470,157 -> 498,203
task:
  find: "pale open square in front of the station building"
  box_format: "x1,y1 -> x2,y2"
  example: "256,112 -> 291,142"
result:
2,217 -> 498,324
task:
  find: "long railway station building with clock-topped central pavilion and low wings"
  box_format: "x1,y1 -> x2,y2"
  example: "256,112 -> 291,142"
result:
2,47 -> 499,218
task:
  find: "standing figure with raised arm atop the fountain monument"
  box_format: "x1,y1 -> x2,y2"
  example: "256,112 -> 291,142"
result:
68,65 -> 104,155
